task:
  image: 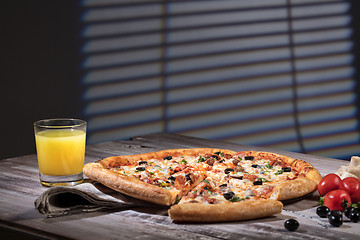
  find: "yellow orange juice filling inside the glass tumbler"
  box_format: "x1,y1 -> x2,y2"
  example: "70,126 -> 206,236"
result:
35,129 -> 86,176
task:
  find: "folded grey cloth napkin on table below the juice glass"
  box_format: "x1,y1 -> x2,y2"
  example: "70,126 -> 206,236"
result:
35,182 -> 154,217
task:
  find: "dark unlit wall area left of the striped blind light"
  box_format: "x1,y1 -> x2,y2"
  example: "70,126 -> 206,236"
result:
0,0 -> 82,159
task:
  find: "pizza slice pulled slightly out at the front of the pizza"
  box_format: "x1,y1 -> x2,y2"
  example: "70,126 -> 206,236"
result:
168,175 -> 283,222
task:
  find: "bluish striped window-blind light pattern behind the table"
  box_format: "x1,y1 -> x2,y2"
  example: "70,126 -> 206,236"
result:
82,0 -> 360,157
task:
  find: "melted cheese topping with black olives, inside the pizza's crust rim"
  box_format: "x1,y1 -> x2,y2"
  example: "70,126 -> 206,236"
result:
112,151 -> 297,204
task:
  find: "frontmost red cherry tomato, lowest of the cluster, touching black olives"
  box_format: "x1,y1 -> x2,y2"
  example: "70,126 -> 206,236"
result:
324,189 -> 351,212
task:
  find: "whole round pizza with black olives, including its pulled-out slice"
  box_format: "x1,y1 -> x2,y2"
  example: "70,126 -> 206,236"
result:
83,148 -> 321,222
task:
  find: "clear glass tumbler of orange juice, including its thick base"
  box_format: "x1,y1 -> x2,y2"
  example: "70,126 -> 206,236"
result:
34,118 -> 86,187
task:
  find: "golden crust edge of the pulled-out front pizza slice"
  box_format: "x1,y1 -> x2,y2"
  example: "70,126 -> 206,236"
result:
168,199 -> 283,222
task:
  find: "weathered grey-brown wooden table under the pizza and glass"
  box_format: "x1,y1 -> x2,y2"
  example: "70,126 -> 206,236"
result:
0,133 -> 360,240
